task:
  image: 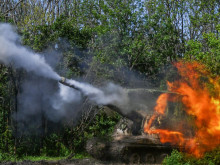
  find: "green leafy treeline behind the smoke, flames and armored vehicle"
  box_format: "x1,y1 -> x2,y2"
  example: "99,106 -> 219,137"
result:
0,0 -> 220,159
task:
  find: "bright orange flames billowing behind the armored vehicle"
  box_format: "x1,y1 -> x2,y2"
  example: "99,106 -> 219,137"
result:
144,61 -> 220,157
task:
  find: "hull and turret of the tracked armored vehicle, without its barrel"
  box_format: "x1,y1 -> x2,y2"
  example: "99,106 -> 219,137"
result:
86,100 -> 179,164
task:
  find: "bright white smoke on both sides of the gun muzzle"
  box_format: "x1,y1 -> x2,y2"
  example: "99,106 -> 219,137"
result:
0,24 -> 127,112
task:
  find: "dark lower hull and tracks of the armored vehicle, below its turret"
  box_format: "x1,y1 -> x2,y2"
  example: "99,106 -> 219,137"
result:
86,135 -> 175,164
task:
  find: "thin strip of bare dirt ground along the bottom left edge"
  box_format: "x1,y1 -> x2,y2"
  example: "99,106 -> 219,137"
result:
0,158 -> 162,165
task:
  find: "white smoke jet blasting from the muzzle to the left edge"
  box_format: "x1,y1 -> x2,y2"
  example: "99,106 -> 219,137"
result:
0,24 -> 60,80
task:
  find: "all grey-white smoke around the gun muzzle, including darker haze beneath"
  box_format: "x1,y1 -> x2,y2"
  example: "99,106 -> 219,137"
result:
0,24 -> 132,129
